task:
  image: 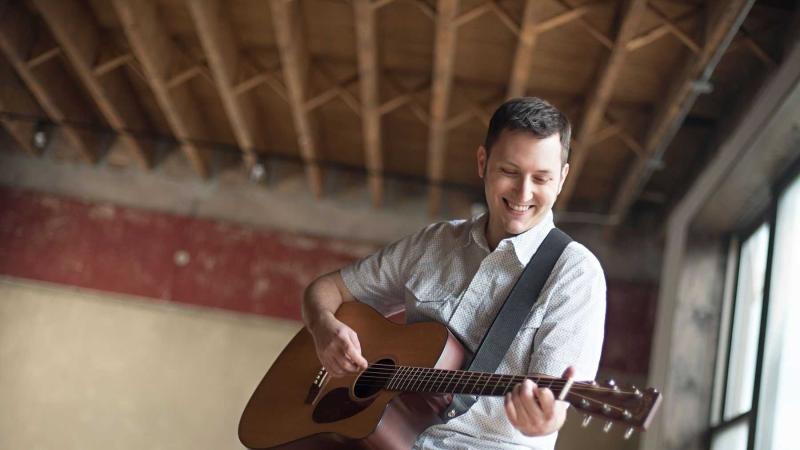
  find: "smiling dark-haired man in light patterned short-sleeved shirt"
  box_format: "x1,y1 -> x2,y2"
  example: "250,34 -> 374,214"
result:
303,97 -> 605,450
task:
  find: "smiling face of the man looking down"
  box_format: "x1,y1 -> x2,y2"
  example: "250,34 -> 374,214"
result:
478,130 -> 569,248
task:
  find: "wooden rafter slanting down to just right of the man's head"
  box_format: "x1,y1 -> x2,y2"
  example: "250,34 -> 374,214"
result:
559,0 -> 647,209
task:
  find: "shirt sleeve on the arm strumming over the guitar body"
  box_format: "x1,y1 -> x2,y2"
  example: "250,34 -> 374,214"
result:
340,227 -> 430,315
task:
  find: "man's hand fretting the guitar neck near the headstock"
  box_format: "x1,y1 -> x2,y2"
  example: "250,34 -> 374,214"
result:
505,367 -> 573,436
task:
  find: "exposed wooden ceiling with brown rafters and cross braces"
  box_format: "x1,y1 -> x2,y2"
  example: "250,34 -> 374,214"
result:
0,0 -> 798,225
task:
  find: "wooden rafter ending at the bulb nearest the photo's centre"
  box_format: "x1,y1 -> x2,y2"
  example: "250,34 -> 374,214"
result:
186,0 -> 266,168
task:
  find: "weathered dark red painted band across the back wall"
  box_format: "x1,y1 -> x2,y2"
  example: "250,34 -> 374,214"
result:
0,187 -> 656,374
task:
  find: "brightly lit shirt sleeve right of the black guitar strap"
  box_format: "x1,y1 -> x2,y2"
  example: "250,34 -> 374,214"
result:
529,243 -> 606,381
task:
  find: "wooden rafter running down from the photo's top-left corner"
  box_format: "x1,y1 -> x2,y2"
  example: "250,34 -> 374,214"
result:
0,2 -> 100,163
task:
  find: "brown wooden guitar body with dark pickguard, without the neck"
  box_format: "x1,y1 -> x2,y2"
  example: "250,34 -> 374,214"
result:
239,302 -> 463,449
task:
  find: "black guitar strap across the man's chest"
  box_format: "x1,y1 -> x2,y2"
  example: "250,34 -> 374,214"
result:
440,228 -> 572,422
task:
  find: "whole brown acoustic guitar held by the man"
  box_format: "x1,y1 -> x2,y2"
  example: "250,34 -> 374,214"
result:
239,302 -> 661,450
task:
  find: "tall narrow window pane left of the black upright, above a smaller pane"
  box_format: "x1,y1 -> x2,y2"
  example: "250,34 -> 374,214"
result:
724,224 -> 769,420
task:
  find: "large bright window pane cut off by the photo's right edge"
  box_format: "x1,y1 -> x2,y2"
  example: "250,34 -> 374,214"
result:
756,173 -> 800,449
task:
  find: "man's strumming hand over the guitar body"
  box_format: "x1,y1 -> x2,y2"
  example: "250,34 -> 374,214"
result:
309,313 -> 369,377
